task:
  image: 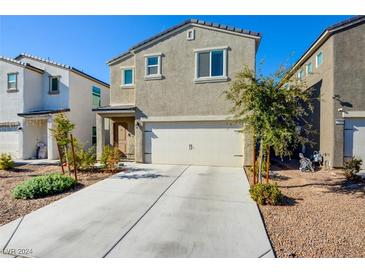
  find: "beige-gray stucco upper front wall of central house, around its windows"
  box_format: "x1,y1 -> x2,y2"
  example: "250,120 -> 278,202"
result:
135,24 -> 256,116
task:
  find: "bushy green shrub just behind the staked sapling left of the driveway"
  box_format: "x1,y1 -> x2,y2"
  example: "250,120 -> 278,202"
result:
67,138 -> 96,170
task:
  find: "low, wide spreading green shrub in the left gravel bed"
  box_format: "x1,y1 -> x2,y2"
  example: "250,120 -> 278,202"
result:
12,173 -> 77,199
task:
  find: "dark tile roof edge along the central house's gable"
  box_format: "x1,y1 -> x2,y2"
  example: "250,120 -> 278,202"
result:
107,19 -> 262,64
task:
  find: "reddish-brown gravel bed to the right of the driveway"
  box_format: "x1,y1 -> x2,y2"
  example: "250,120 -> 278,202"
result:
247,161 -> 365,258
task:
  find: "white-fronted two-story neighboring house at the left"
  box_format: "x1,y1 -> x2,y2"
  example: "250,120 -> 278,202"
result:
0,54 -> 109,159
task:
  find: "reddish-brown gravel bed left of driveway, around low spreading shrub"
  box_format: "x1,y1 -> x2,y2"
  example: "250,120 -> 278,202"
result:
0,165 -> 112,226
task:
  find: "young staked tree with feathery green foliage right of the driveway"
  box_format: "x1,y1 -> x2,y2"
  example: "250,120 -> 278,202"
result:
224,67 -> 312,182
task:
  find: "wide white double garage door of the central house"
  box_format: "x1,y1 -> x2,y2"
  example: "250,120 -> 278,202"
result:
144,122 -> 243,167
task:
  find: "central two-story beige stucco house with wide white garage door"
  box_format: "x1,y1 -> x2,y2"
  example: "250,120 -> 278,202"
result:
95,20 -> 261,166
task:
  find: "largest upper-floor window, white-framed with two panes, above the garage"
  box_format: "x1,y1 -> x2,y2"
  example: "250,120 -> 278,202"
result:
195,48 -> 227,81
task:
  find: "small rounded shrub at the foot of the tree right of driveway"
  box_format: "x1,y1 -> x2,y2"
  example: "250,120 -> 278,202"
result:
250,183 -> 283,205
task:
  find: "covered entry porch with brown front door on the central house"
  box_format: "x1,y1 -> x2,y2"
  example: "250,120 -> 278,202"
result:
94,106 -> 135,161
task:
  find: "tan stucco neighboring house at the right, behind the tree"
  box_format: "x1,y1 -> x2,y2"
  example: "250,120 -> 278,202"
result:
291,16 -> 365,168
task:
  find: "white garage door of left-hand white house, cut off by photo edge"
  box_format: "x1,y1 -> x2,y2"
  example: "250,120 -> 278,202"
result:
0,122 -> 20,159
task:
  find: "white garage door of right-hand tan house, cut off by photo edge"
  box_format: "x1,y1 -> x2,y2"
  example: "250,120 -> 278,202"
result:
344,119 -> 365,168
